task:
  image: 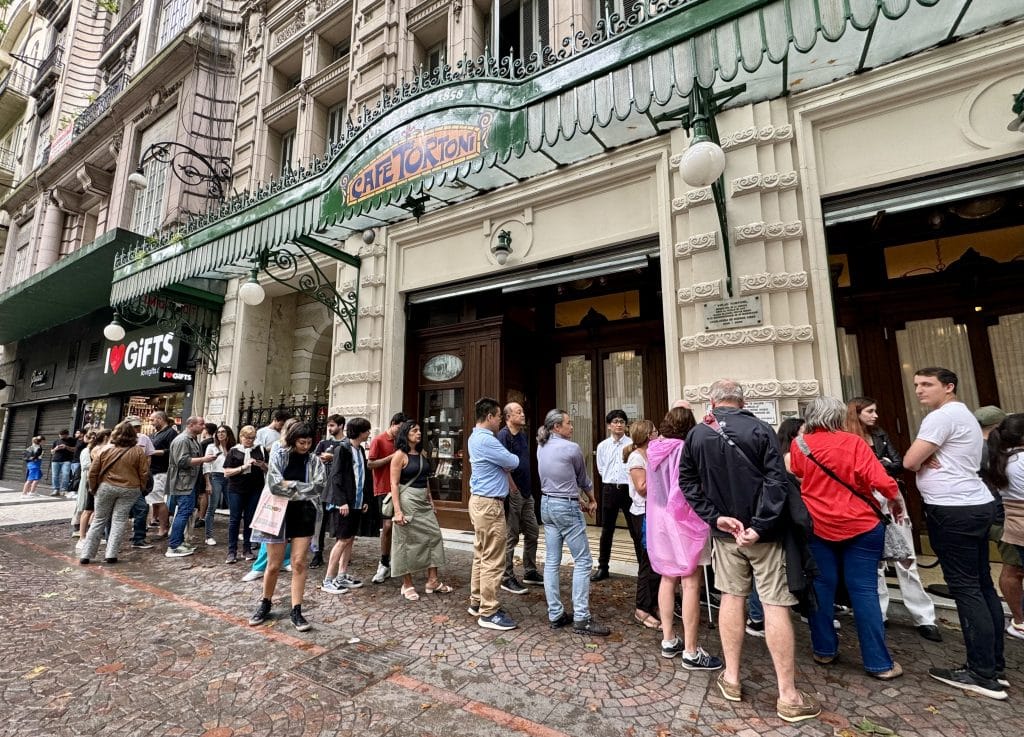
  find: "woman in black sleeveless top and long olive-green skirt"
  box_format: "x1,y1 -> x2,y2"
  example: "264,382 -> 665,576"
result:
391,420 -> 453,601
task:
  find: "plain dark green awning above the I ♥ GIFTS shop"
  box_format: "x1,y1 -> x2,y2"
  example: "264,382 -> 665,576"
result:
0,228 -> 141,344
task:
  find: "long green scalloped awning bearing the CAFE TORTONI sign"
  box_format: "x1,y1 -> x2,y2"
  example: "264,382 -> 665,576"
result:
111,0 -> 1024,305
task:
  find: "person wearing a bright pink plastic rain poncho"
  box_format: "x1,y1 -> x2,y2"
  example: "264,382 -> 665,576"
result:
647,407 -> 723,670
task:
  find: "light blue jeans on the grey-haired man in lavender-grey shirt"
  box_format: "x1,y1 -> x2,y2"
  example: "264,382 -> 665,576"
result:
541,496 -> 594,621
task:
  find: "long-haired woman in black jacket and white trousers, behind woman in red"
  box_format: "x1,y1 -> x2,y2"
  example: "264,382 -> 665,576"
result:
846,397 -> 942,642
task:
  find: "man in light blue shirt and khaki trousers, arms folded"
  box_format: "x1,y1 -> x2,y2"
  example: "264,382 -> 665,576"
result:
468,397 -> 519,630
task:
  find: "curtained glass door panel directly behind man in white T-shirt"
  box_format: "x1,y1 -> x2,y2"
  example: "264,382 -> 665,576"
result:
896,317 -> 978,437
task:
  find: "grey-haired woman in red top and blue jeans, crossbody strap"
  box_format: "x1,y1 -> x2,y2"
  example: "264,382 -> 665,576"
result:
790,397 -> 903,681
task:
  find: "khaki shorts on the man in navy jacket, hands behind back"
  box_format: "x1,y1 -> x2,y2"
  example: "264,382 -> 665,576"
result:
712,537 -> 797,606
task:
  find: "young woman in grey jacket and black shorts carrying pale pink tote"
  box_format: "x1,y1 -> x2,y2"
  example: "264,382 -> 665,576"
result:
249,423 -> 327,632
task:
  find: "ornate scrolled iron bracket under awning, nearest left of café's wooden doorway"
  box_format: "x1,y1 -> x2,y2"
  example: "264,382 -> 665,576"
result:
255,235 -> 360,353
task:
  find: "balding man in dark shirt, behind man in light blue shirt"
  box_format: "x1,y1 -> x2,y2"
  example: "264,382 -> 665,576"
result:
498,402 -> 544,594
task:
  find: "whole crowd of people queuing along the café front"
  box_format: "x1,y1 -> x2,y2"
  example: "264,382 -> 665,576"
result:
48,367 -> 1024,722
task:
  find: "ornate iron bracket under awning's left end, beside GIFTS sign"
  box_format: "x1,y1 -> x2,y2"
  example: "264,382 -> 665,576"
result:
117,294 -> 220,374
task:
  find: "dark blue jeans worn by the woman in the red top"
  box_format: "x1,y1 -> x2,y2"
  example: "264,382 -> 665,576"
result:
808,522 -> 893,673
